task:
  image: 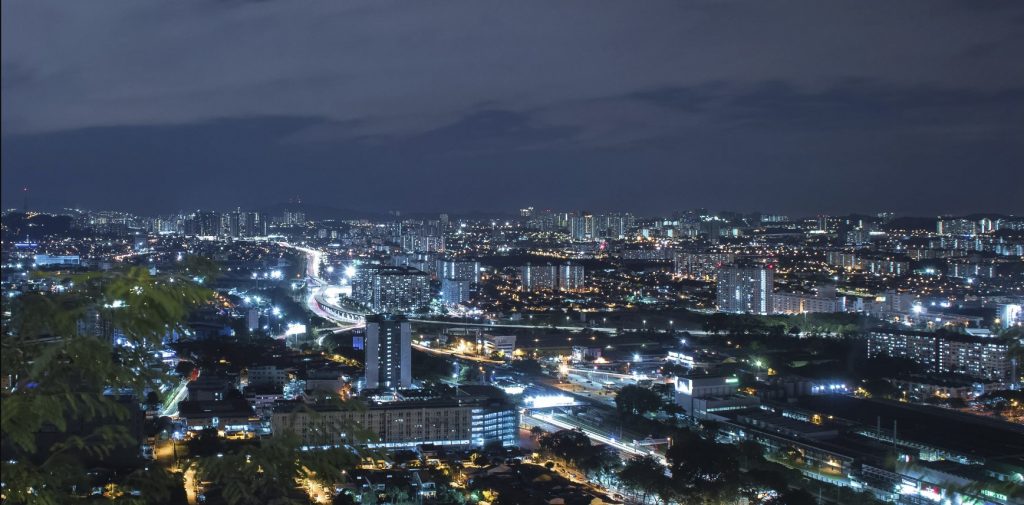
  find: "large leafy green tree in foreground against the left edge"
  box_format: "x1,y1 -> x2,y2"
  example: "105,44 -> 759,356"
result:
0,267 -> 210,504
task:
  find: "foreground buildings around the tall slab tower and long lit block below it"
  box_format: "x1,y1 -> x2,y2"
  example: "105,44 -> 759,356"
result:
169,313 -> 519,450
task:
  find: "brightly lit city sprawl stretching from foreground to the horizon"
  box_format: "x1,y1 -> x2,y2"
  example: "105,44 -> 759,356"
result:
2,204 -> 1024,505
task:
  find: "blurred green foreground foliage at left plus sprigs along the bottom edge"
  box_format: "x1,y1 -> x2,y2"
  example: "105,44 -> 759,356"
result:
0,268 -> 364,505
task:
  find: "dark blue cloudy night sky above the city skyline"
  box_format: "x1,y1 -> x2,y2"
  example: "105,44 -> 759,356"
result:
2,0 -> 1024,215
